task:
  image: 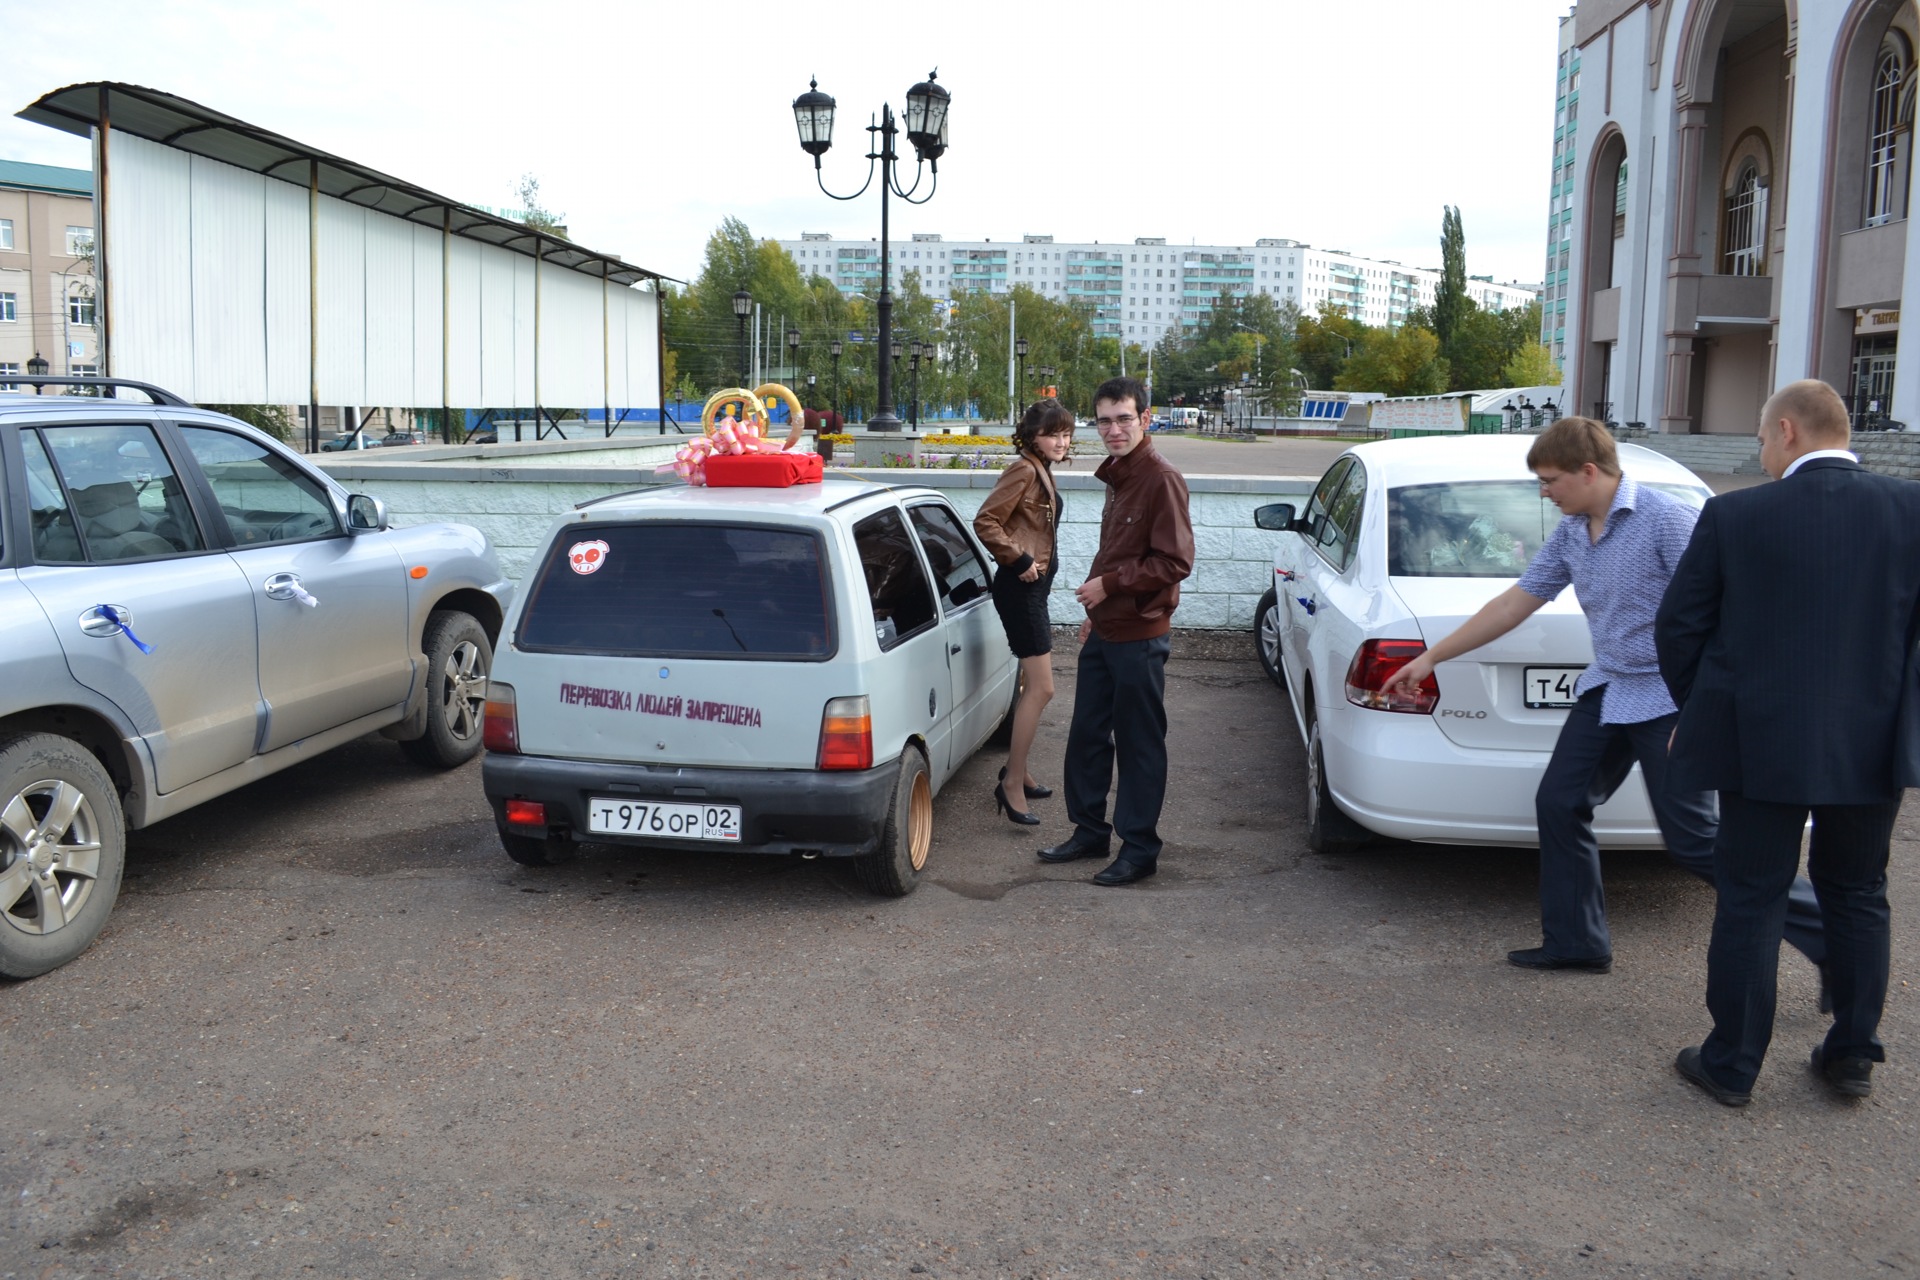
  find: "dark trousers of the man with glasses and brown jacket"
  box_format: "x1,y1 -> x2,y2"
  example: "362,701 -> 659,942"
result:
1062,631 -> 1171,867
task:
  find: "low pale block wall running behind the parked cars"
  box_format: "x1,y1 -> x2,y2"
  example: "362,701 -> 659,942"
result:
315,455 -> 1319,629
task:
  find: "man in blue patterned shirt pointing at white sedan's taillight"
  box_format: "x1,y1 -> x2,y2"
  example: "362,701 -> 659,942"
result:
1388,418 -> 1826,982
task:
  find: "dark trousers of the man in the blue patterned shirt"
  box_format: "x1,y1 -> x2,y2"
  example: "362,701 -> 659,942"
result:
1534,685 -> 1826,965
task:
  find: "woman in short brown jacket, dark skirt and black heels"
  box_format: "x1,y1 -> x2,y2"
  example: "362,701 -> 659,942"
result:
973,399 -> 1073,827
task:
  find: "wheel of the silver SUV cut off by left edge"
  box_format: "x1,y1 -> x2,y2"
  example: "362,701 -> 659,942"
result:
0,733 -> 127,979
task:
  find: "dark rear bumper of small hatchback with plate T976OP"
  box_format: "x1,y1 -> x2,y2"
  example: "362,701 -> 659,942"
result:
480,752 -> 899,858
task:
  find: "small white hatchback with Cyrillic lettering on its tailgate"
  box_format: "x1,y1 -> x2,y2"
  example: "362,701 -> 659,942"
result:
482,480 -> 1018,896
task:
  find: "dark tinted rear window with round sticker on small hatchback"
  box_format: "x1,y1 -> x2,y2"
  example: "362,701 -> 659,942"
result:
518,520 -> 833,660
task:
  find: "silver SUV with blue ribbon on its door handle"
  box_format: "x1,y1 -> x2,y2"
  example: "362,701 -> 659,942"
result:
0,378 -> 511,977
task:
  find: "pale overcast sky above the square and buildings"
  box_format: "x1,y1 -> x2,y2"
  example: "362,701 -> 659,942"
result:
0,0 -> 1567,282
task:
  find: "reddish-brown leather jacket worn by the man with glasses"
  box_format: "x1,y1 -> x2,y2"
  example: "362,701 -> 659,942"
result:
1087,438 -> 1194,645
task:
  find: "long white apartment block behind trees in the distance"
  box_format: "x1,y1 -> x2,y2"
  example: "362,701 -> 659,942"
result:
778,232 -> 1538,345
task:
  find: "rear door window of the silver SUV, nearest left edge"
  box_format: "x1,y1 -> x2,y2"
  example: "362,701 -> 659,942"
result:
35,424 -> 205,564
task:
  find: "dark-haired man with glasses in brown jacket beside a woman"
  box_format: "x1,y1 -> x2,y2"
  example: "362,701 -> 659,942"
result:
1041,378 -> 1194,885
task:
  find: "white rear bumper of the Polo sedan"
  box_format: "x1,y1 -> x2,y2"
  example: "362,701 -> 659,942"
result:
1321,704 -> 1665,848
